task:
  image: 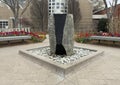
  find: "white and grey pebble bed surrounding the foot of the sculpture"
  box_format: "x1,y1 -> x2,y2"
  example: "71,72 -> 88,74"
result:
27,46 -> 95,64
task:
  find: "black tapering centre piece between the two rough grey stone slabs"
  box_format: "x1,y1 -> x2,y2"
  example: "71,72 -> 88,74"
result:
54,14 -> 66,55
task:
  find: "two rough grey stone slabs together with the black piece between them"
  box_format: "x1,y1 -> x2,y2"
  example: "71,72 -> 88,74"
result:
48,14 -> 74,56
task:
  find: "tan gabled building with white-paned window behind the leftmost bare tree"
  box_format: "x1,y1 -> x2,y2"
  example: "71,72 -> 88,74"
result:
0,2 -> 30,29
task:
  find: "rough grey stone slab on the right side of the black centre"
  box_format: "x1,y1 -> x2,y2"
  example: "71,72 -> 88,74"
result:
62,14 -> 74,55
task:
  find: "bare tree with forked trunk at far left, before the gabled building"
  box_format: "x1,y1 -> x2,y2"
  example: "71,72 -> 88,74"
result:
0,0 -> 31,28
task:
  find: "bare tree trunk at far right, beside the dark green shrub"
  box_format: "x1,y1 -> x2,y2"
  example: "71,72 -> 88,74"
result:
103,0 -> 118,32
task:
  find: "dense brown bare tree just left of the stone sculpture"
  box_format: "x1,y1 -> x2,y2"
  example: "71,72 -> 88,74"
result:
31,0 -> 48,31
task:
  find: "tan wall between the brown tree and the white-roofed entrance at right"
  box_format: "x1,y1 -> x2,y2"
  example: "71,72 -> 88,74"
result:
79,0 -> 94,32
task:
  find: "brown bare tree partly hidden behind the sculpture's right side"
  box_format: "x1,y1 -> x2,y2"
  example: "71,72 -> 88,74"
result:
68,0 -> 81,31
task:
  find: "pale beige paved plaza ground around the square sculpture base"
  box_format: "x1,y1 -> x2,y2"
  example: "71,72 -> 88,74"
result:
0,39 -> 120,85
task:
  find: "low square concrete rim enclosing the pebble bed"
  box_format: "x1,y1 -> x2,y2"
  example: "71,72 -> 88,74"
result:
19,48 -> 103,76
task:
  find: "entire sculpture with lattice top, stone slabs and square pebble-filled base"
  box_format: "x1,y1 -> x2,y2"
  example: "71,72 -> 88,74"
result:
19,0 -> 103,75
